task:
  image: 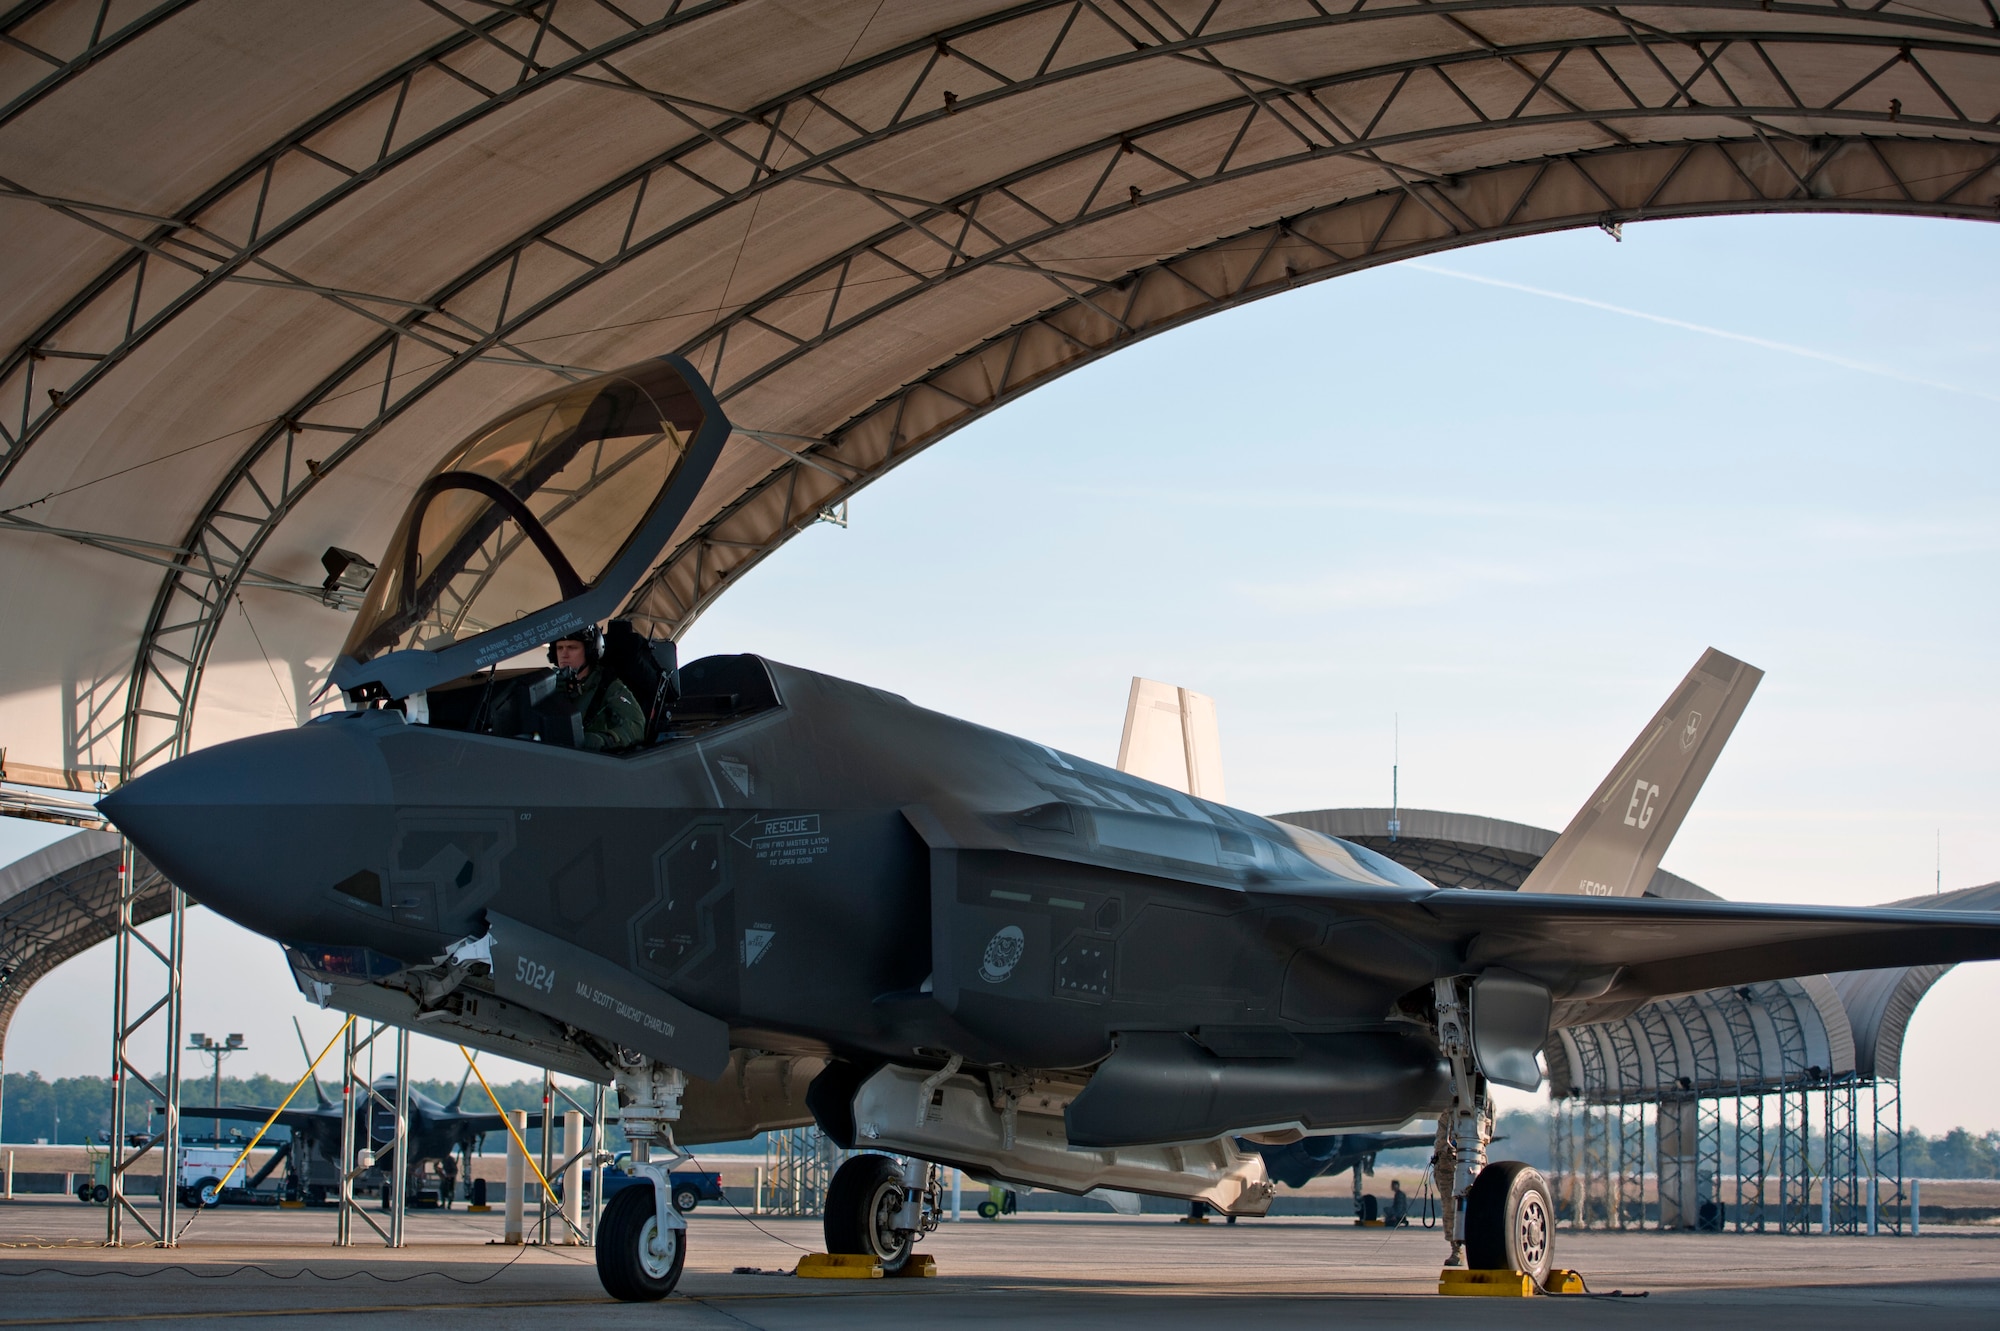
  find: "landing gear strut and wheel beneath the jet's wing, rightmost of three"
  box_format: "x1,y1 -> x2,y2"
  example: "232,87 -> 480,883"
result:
1430,977 -> 1556,1289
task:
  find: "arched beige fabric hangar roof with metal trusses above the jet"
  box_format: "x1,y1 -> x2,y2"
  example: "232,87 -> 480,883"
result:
0,0 -> 2000,787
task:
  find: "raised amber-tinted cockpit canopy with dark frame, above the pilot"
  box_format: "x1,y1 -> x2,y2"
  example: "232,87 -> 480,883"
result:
334,358 -> 728,697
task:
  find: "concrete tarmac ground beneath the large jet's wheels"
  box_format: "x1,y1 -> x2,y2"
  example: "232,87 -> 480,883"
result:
0,1201 -> 2000,1331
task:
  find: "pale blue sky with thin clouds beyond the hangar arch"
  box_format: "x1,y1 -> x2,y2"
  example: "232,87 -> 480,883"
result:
0,218 -> 2000,1135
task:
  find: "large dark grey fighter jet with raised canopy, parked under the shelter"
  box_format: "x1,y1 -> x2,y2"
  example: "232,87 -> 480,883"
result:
102,358 -> 2000,1299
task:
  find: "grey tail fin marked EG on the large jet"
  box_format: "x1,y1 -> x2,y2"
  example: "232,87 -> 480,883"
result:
1520,648 -> 1764,897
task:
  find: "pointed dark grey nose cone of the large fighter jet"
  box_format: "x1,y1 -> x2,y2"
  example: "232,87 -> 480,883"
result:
98,717 -> 400,941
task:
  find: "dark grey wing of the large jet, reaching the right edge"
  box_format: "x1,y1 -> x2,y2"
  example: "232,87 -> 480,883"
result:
1410,891 -> 2000,1025
